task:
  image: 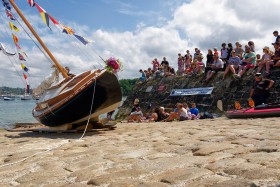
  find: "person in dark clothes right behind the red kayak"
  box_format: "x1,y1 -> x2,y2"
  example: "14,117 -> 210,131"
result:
250,73 -> 274,106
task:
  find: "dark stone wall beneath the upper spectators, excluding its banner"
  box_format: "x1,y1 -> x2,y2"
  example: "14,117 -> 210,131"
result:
116,69 -> 280,119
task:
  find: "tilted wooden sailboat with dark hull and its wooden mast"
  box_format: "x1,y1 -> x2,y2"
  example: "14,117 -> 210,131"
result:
9,0 -> 122,127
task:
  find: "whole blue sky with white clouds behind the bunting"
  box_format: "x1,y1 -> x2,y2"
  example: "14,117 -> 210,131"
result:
0,0 -> 280,88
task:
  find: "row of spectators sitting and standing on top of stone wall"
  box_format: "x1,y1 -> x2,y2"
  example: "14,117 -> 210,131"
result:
139,31 -> 280,82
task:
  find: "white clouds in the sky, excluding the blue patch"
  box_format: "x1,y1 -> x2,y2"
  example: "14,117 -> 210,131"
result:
0,0 -> 280,87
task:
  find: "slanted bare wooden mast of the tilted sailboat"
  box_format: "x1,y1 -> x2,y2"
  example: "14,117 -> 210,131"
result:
9,0 -> 68,78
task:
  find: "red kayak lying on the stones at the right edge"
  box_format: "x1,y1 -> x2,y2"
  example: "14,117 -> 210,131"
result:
225,103 -> 280,118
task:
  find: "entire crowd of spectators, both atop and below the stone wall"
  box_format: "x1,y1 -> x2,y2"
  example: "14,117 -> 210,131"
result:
128,31 -> 280,122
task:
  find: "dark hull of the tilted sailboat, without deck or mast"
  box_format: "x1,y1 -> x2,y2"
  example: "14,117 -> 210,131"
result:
33,72 -> 122,127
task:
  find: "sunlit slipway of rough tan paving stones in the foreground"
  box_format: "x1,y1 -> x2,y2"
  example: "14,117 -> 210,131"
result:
0,118 -> 280,187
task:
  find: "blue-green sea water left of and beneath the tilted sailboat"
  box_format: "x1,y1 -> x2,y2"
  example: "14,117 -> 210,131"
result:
0,97 -> 126,128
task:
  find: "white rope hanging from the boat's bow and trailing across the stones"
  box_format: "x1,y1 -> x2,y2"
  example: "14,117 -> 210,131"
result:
0,77 -> 96,168
